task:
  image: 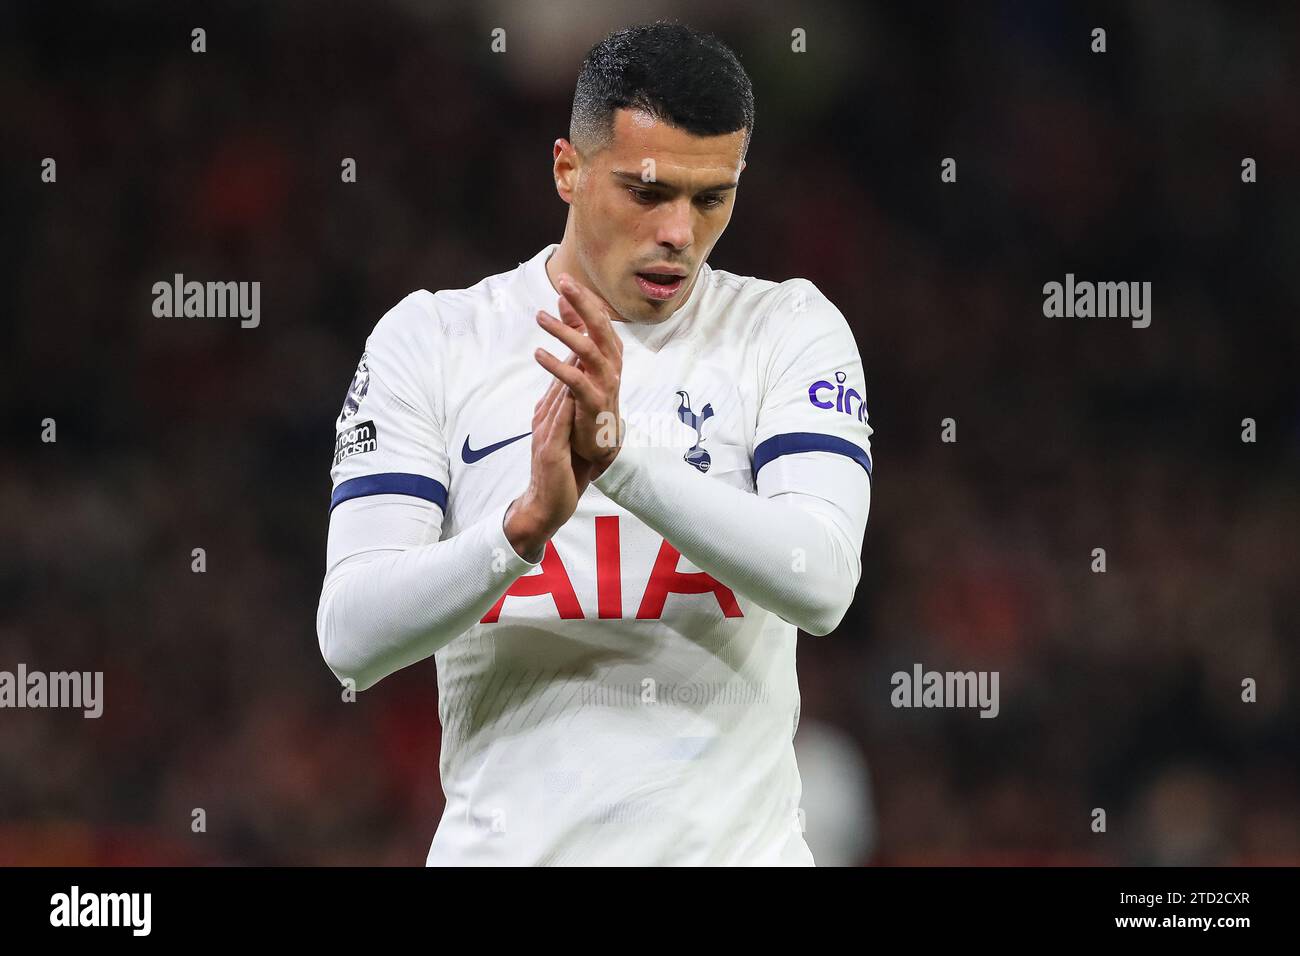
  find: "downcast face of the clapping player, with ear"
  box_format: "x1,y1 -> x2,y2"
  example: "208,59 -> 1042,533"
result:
555,109 -> 745,323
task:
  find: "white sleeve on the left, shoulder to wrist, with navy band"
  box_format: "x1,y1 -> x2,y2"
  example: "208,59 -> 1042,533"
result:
316,293 -> 537,691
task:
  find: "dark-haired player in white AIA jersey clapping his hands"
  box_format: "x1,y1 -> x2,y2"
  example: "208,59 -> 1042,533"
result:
317,23 -> 871,865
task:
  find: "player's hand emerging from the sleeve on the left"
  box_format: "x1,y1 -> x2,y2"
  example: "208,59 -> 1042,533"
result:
504,355 -> 592,562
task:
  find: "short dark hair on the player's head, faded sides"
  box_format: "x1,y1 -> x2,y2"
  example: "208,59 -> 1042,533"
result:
569,21 -> 754,155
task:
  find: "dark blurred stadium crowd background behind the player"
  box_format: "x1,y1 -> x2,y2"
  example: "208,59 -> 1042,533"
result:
0,0 -> 1300,865
